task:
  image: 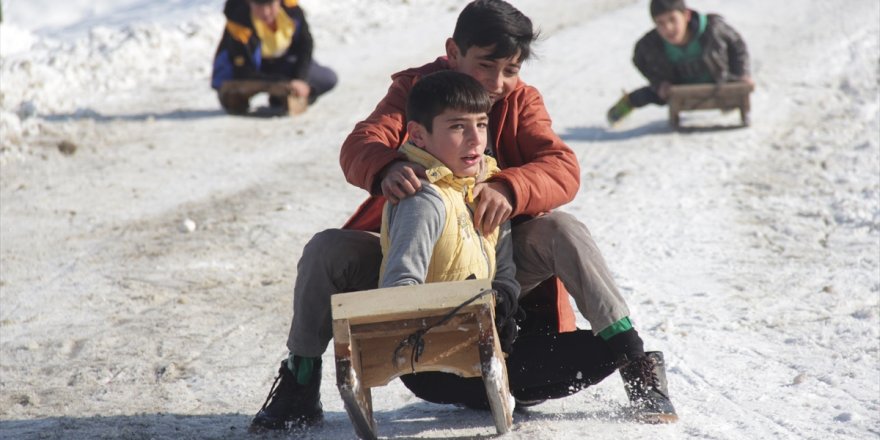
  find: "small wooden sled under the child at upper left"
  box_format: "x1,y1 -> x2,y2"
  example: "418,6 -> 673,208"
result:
219,80 -> 309,116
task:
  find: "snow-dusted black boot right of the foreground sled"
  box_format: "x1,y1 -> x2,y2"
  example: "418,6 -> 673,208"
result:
620,351 -> 678,423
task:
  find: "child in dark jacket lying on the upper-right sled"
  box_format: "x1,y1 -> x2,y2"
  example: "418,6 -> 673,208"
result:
607,0 -> 754,125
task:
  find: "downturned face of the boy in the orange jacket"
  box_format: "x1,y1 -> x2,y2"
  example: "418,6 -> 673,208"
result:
446,38 -> 522,102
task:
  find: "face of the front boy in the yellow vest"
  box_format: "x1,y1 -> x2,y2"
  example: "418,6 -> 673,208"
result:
408,109 -> 489,177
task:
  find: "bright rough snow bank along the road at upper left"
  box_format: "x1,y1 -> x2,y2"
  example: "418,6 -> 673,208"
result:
0,6 -> 223,161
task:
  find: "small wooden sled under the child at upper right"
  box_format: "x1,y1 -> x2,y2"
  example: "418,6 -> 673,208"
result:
667,82 -> 754,130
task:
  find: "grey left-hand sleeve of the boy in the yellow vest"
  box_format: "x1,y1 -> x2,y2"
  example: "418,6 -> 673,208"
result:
379,182 -> 446,288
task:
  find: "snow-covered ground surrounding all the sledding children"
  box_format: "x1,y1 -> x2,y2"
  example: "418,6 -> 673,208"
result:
0,0 -> 880,439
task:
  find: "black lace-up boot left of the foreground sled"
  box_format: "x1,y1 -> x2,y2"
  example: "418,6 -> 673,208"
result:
248,358 -> 324,433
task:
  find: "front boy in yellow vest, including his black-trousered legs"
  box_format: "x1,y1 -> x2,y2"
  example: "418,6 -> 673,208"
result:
379,70 -> 675,421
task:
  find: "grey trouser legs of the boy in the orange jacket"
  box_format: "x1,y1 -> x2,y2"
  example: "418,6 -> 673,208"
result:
287,212 -> 629,357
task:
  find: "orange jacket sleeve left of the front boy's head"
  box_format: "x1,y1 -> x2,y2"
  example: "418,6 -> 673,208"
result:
339,76 -> 413,194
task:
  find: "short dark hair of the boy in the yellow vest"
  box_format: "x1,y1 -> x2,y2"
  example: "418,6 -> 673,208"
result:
406,70 -> 492,133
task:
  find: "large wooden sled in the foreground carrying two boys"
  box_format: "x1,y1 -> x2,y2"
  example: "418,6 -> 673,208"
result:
331,280 -> 513,439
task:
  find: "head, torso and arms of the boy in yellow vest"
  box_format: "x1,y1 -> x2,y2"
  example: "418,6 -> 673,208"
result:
379,70 -> 520,352
